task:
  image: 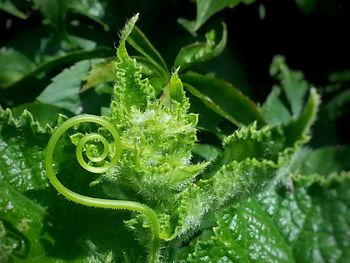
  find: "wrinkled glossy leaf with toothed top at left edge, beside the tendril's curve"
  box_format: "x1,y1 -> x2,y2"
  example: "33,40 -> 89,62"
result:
0,110 -> 51,193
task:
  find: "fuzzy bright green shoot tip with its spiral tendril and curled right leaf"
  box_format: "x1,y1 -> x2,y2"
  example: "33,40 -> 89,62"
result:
41,17 -> 318,262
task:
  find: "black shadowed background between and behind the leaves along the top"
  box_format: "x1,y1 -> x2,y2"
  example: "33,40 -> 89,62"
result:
0,0 -> 350,89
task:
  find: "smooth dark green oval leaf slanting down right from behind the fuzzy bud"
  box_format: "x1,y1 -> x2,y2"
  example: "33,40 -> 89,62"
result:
181,72 -> 264,127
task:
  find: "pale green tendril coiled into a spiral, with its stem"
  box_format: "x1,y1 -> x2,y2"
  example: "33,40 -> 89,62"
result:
45,115 -> 160,263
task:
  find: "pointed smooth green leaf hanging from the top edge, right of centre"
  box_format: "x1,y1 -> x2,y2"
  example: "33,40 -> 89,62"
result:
178,0 -> 255,34
